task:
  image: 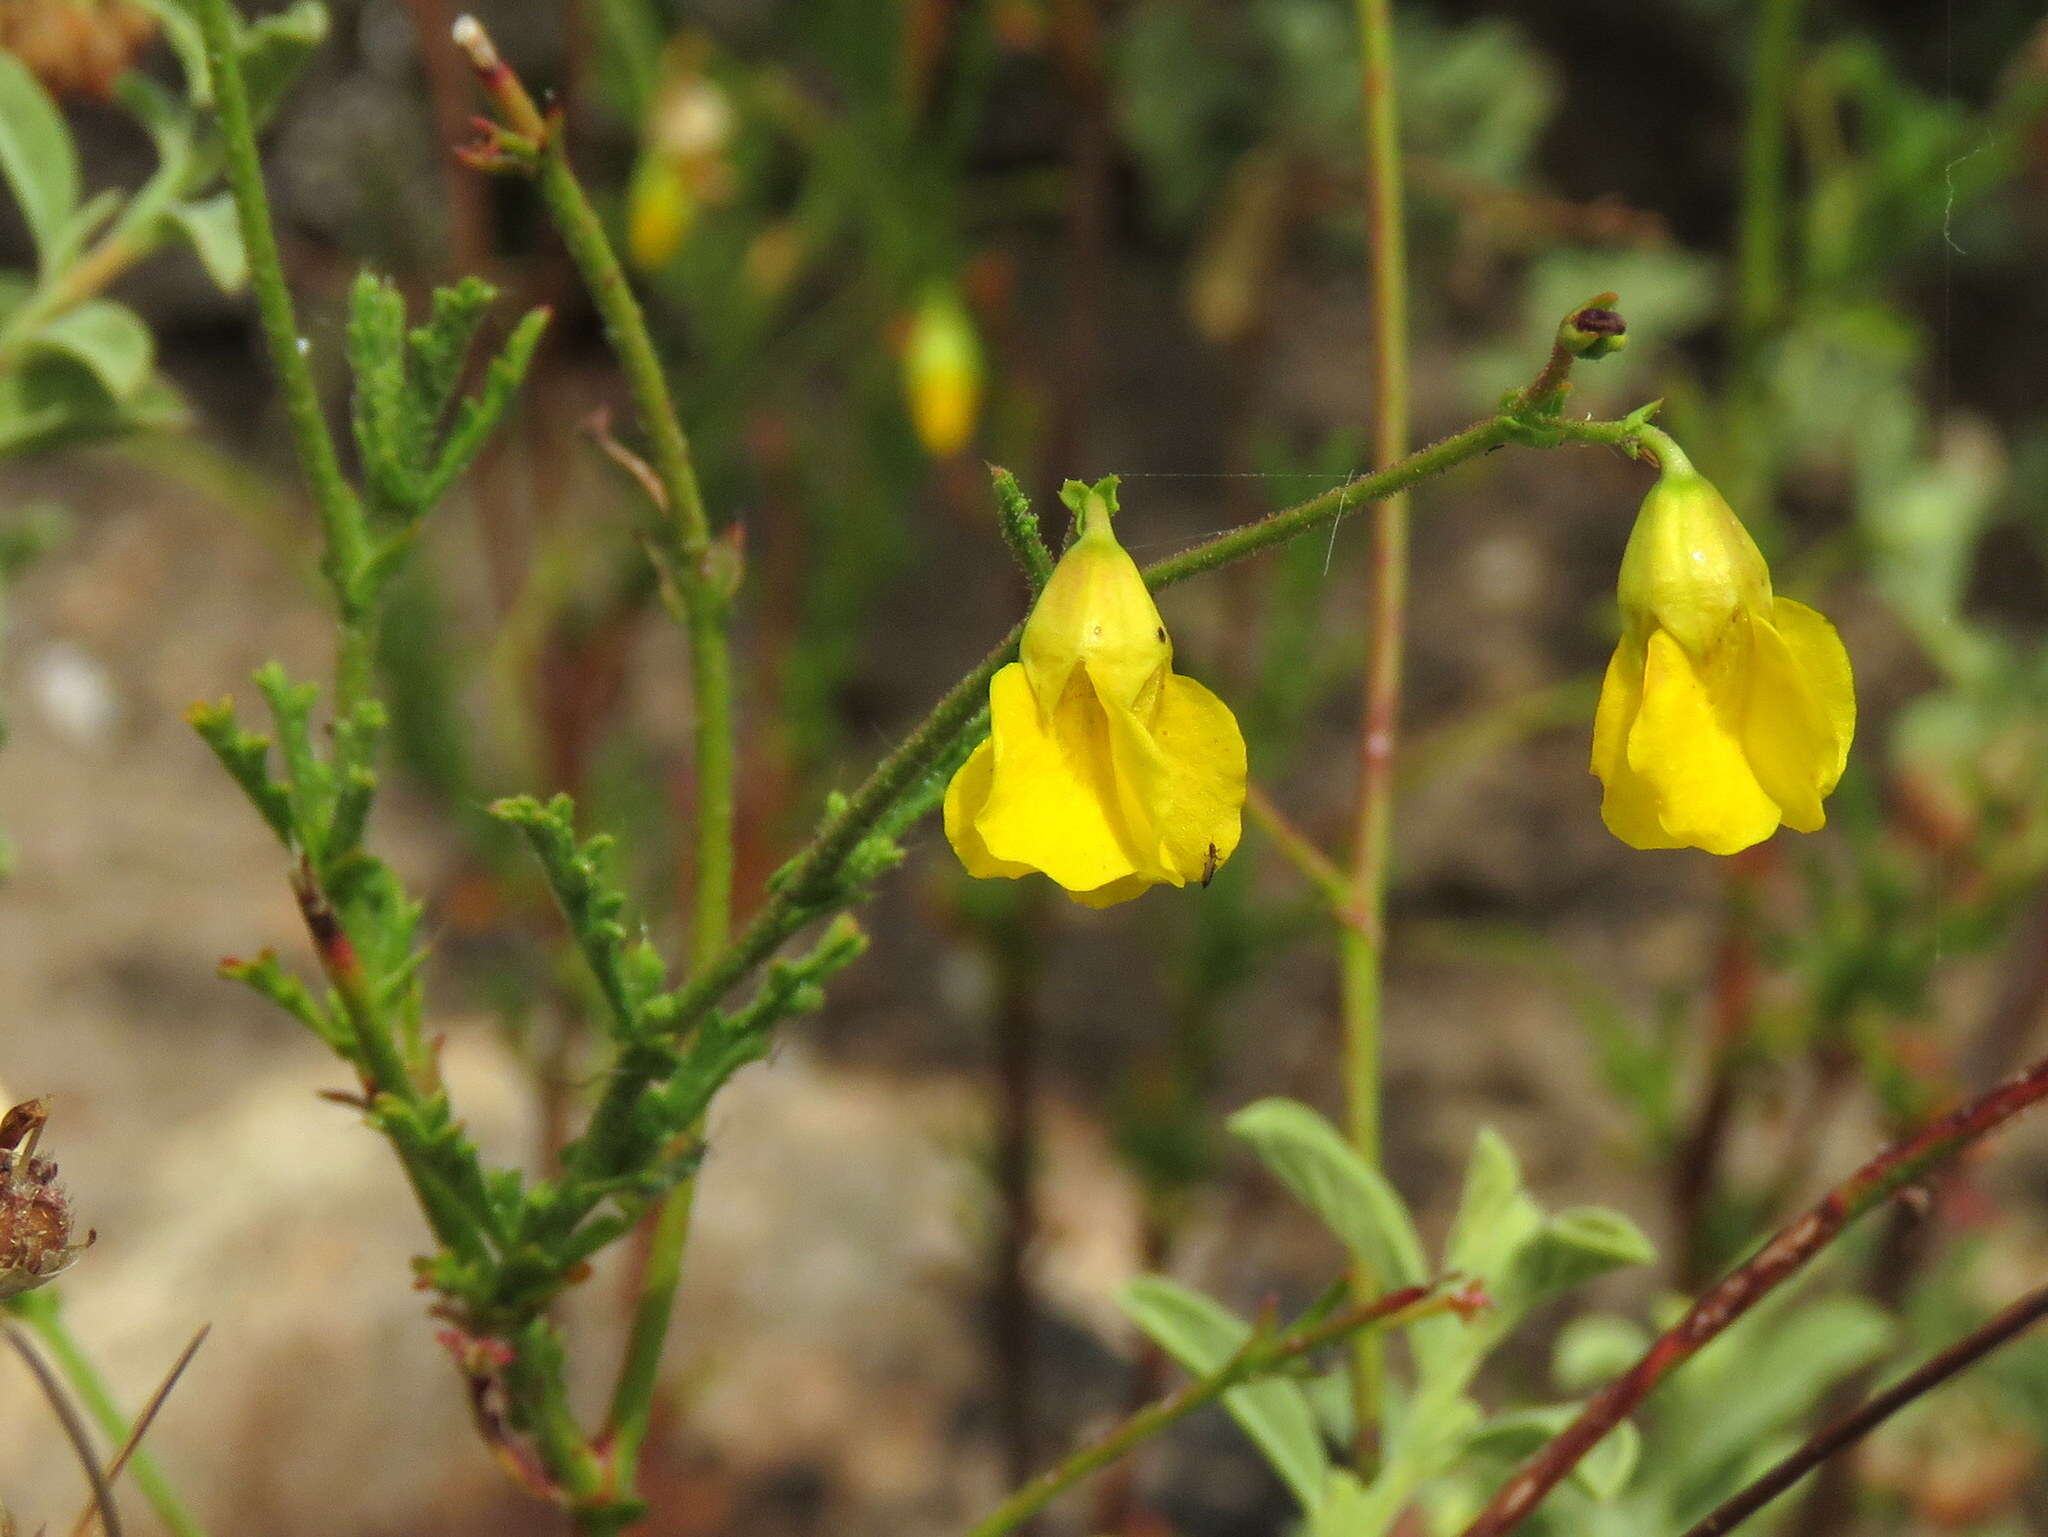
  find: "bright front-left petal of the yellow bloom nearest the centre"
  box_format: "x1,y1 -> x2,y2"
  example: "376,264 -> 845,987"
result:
963,662 -> 1141,891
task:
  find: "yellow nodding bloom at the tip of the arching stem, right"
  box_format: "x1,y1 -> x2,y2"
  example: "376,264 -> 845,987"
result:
1593,439 -> 1855,855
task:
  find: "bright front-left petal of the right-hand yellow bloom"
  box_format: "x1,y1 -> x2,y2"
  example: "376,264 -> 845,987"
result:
1628,629 -> 1780,855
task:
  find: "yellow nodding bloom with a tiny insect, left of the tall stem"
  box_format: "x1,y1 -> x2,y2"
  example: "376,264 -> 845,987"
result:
946,475 -> 1245,908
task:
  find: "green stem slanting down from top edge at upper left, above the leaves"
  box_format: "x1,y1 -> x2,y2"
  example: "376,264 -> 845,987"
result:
199,0 -> 375,719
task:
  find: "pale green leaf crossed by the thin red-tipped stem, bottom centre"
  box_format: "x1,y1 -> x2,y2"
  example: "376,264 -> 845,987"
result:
1116,1275 -> 1331,1512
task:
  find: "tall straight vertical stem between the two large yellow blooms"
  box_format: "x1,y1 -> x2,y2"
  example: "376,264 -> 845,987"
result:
1337,0 -> 1409,1471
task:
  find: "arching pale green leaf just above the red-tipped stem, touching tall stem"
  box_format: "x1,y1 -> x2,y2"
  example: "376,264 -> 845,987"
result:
1231,1098 -> 1430,1289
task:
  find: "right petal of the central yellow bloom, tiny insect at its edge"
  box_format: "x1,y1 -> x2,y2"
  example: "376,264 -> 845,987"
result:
1108,672 -> 1245,885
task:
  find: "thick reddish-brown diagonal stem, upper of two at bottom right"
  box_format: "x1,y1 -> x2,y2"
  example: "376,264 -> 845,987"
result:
1464,1057 -> 2048,1537
